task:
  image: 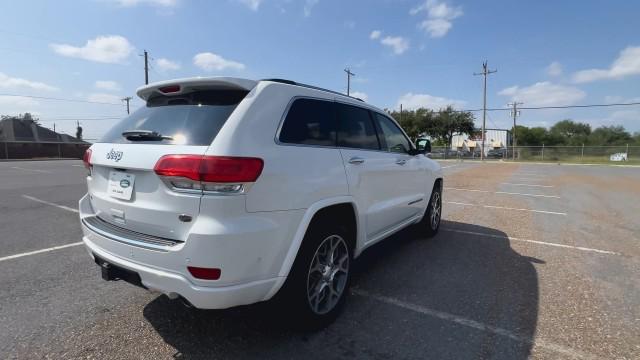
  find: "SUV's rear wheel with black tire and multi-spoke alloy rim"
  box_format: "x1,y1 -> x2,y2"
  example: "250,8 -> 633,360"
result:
278,217 -> 353,330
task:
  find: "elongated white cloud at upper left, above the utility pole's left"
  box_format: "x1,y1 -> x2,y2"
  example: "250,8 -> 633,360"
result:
49,35 -> 134,63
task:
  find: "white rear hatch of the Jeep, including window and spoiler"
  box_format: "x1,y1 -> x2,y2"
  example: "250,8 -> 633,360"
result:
87,82 -> 255,241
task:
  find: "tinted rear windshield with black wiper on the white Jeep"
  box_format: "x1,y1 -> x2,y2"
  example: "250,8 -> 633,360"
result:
99,90 -> 248,145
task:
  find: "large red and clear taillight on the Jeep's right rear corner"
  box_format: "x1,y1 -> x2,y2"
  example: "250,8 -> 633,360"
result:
153,155 -> 264,193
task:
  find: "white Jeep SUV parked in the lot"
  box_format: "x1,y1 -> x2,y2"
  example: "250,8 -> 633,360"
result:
79,77 -> 442,321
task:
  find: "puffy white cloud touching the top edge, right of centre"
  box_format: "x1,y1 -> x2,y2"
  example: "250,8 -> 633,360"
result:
409,0 -> 464,38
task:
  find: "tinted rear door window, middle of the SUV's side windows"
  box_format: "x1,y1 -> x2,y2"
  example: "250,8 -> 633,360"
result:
336,104 -> 380,150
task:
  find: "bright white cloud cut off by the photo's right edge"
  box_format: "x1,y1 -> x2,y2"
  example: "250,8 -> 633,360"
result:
573,46 -> 640,83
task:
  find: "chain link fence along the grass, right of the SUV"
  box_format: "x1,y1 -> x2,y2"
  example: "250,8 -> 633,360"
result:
430,145 -> 640,164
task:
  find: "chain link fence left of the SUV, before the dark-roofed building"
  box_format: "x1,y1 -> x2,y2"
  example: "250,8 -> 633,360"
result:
0,141 -> 91,160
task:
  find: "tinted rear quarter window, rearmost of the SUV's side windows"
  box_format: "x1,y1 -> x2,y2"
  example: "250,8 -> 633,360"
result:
280,99 -> 336,146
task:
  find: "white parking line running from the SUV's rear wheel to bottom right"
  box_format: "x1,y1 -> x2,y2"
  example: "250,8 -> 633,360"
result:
351,288 -> 597,359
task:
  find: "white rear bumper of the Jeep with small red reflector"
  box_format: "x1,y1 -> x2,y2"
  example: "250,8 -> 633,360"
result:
79,195 -> 302,309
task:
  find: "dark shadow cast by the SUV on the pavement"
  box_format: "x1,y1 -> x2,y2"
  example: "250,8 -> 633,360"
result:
144,220 -> 544,359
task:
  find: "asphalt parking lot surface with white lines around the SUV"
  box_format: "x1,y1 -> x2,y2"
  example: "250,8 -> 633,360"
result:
0,161 -> 640,359
